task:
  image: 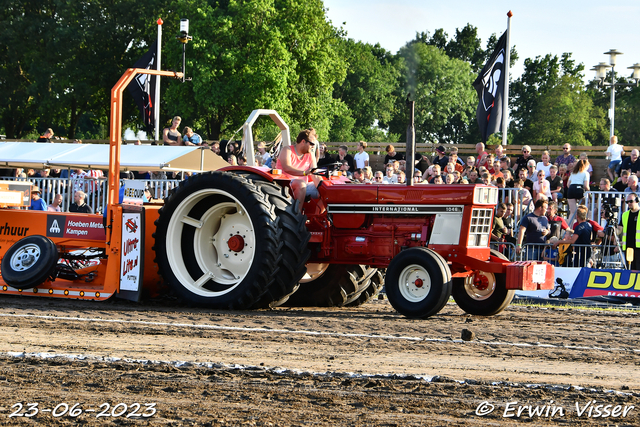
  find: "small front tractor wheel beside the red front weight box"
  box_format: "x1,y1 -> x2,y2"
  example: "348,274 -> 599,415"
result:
451,249 -> 515,316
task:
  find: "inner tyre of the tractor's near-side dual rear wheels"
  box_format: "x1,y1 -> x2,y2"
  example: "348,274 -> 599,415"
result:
249,181 -> 311,308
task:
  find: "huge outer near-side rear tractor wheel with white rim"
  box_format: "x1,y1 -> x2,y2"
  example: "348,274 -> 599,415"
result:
154,172 -> 281,310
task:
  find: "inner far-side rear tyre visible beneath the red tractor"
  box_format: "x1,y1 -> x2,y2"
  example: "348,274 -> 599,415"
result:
285,264 -> 366,307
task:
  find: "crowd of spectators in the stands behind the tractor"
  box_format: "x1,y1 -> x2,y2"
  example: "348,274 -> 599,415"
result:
11,123 -> 640,266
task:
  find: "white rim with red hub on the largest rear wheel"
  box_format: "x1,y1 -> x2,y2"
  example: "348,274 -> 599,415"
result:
166,189 -> 256,297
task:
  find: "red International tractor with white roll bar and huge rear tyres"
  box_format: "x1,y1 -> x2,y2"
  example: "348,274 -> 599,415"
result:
154,110 -> 554,318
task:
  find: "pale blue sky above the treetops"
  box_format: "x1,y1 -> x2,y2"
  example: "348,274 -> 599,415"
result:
324,0 -> 640,80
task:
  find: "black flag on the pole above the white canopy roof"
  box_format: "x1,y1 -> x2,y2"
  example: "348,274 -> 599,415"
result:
128,42 -> 158,135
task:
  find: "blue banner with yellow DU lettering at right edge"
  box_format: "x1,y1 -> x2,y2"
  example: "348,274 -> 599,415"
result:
569,268 -> 640,298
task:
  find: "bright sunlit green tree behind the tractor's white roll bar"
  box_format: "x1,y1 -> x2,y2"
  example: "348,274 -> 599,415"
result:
168,0 -> 345,139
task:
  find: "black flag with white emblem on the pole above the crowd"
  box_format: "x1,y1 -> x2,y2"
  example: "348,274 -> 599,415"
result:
473,31 -> 508,142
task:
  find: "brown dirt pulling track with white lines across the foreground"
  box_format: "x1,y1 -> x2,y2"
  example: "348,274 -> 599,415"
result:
0,297 -> 640,426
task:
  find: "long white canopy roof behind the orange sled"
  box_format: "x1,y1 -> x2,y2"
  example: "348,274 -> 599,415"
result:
0,142 -> 229,172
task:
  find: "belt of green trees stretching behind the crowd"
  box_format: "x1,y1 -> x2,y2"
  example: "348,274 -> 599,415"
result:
0,0 -> 640,149
